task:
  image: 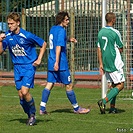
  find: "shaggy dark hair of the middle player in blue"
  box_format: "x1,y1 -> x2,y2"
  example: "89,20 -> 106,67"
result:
55,11 -> 69,25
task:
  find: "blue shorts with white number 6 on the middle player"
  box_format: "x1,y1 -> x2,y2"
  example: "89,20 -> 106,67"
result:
47,70 -> 71,85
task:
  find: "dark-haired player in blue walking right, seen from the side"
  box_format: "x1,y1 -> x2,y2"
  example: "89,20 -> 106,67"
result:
40,11 -> 90,115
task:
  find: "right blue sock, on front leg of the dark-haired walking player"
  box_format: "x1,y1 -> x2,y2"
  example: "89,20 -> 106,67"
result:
66,90 -> 79,111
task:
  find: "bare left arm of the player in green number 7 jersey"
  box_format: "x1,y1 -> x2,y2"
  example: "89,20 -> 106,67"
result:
97,47 -> 104,74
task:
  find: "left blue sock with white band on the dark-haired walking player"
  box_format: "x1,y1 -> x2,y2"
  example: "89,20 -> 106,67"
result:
40,88 -> 50,111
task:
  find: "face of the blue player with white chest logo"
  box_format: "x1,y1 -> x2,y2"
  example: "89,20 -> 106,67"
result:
7,19 -> 20,34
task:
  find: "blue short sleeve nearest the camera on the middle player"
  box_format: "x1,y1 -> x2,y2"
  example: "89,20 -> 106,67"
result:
57,29 -> 66,47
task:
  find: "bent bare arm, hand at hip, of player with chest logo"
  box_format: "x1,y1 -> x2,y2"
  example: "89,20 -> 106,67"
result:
33,42 -> 47,66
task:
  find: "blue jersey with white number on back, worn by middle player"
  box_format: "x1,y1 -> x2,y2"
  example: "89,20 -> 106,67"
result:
48,25 -> 68,71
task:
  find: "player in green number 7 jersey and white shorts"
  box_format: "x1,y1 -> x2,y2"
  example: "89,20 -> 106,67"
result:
97,12 -> 125,114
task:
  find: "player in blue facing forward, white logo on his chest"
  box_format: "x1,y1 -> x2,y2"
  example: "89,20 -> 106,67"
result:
0,12 -> 46,125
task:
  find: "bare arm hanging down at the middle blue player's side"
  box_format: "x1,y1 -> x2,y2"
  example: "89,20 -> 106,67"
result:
54,46 -> 61,71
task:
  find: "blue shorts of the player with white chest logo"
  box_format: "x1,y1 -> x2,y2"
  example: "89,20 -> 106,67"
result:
14,64 -> 36,90
